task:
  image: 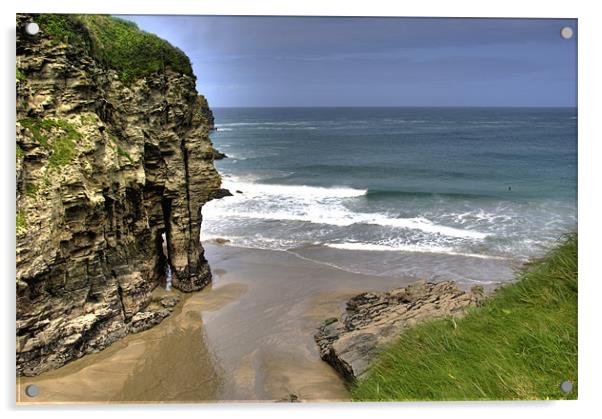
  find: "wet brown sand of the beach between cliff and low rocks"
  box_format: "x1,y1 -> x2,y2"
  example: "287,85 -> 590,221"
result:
17,244 -> 428,403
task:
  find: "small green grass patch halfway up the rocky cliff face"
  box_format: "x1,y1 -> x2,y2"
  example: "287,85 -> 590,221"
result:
17,118 -> 81,169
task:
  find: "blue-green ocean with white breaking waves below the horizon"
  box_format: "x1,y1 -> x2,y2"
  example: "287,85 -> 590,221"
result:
201,108 -> 577,282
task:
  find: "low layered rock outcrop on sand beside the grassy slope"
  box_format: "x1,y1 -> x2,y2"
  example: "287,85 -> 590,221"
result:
315,281 -> 483,380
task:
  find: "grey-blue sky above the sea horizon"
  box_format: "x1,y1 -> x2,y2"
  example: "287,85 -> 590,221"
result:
121,16 -> 577,107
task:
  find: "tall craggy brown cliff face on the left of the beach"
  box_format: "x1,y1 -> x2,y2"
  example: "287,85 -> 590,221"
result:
16,15 -> 223,375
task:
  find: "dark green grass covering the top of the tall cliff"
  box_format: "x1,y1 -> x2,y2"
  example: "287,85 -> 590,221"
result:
37,14 -> 193,83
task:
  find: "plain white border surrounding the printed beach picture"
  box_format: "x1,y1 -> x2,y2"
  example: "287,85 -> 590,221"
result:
0,0 -> 602,419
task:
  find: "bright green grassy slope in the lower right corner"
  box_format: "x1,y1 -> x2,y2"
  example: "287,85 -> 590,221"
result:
352,234 -> 577,401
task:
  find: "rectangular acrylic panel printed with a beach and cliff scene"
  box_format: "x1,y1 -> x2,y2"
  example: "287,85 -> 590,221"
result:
15,14 -> 578,404
